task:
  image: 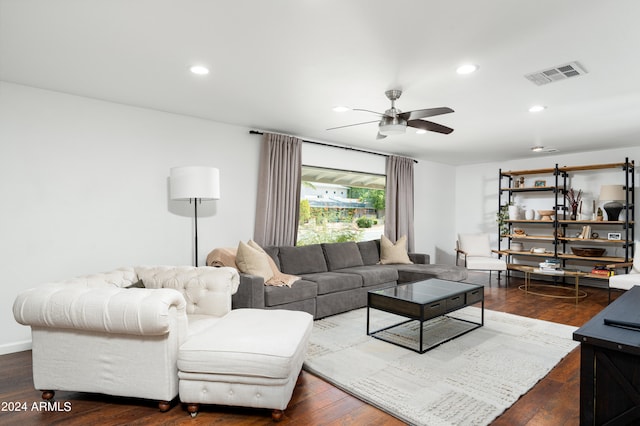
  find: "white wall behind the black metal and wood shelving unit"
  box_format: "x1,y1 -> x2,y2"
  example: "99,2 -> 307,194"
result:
450,148 -> 640,251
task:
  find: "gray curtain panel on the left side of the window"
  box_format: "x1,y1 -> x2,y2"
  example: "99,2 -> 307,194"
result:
253,133 -> 302,247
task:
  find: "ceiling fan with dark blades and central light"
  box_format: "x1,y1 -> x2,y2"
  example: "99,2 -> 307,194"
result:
327,90 -> 453,139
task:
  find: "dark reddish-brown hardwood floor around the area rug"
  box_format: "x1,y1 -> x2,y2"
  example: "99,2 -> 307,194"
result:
0,273 -> 617,426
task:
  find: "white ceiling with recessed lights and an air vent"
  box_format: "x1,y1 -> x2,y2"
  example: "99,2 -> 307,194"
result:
0,0 -> 640,164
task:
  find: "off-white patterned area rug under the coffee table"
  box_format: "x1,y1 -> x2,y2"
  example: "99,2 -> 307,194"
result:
304,307 -> 578,426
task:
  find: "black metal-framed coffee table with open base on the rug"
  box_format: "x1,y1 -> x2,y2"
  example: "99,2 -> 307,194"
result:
367,278 -> 484,353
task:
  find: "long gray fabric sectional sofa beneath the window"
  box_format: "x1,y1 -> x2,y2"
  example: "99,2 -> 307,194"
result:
232,240 -> 467,319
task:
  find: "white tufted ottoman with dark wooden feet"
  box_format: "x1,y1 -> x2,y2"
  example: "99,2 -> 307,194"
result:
178,309 -> 313,421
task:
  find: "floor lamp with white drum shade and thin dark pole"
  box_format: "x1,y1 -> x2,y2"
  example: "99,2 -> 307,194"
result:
169,166 -> 220,266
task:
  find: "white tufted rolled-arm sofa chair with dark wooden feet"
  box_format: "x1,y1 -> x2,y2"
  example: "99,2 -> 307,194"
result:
13,266 -> 239,411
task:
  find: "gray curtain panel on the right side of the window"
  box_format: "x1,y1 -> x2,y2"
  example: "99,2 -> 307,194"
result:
384,156 -> 414,251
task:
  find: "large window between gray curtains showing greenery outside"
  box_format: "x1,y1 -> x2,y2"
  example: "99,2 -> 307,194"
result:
298,166 -> 386,245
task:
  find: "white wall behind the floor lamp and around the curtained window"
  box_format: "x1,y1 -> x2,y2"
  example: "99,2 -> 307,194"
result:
0,82 -> 455,354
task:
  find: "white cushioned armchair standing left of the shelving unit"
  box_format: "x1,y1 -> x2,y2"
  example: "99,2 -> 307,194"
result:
456,233 -> 507,282
